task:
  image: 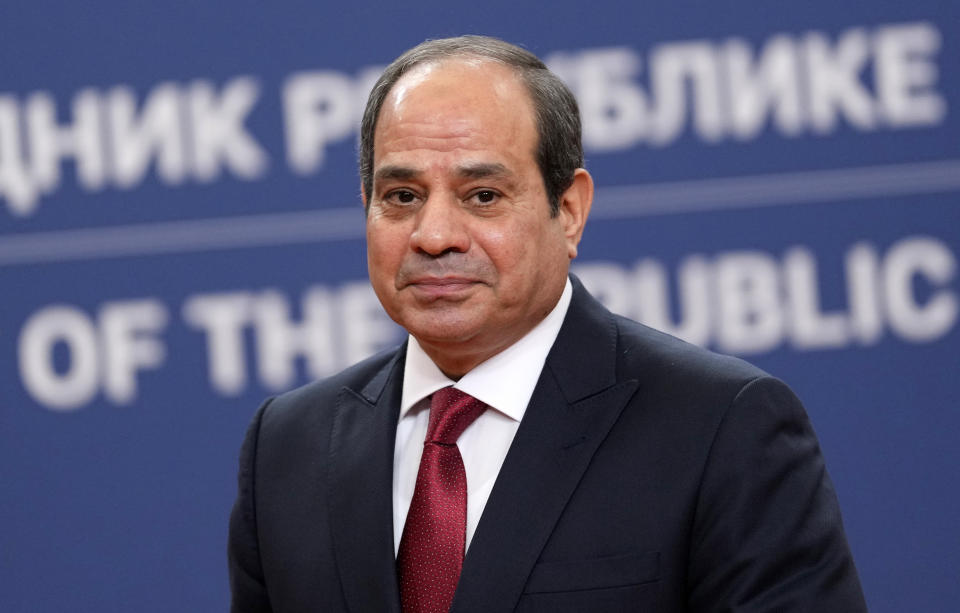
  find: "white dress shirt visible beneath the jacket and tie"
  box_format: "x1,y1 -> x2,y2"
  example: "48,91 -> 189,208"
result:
393,279 -> 573,553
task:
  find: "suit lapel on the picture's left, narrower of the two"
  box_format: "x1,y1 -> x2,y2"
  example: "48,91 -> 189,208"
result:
328,345 -> 406,612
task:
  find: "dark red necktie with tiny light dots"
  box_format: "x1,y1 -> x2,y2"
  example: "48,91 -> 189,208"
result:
397,387 -> 487,613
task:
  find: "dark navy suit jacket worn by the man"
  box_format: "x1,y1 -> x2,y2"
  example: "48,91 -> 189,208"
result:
229,279 -> 866,613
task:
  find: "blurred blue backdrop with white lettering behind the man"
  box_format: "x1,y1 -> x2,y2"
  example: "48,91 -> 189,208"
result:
0,0 -> 960,612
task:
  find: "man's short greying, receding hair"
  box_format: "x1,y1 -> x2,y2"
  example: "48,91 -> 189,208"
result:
360,36 -> 583,216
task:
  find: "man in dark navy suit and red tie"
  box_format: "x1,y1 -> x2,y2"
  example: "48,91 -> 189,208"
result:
229,37 -> 865,613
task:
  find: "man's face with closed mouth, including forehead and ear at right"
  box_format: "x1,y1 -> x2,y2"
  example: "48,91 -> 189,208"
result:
367,59 -> 589,376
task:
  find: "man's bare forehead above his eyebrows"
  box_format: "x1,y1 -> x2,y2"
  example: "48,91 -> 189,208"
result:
374,58 -> 537,165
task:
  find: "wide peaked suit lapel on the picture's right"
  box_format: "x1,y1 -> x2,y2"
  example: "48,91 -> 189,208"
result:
451,278 -> 638,613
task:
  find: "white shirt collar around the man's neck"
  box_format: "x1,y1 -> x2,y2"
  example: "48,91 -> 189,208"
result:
400,278 -> 573,421
